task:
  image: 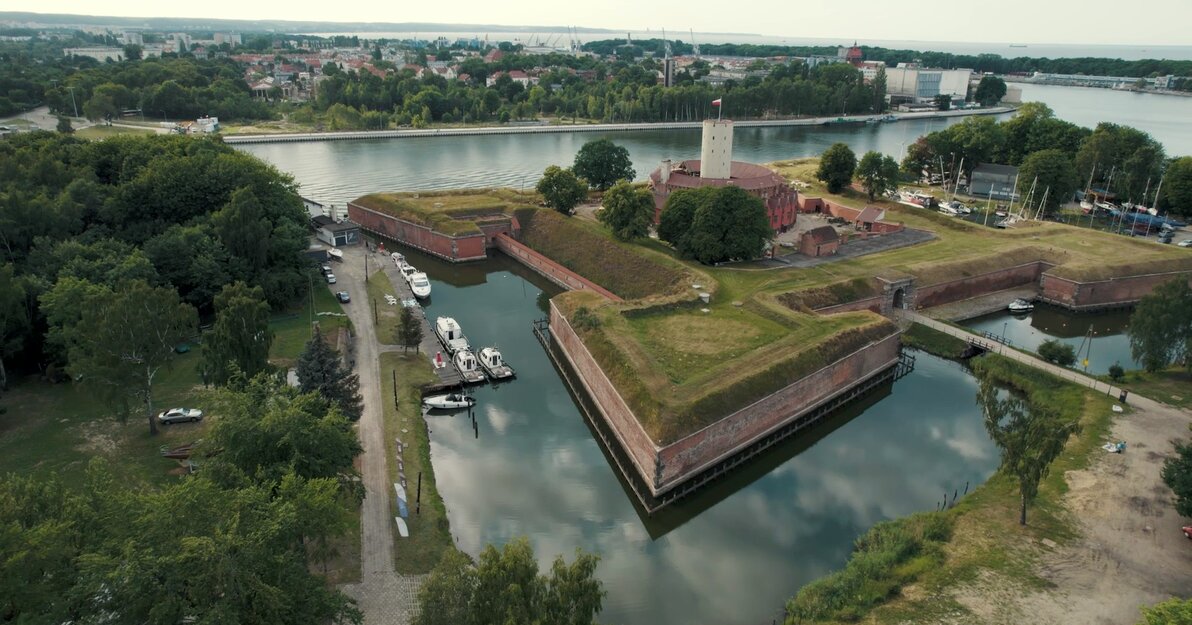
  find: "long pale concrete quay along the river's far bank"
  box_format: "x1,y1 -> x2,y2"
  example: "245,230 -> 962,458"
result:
223,106 -> 1013,144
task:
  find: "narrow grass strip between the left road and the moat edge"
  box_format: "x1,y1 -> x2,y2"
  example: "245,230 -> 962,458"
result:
380,352 -> 454,574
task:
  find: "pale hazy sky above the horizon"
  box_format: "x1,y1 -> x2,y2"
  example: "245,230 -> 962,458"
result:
9,0 -> 1192,45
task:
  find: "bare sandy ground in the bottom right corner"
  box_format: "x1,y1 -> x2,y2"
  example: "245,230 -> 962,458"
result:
957,388 -> 1192,625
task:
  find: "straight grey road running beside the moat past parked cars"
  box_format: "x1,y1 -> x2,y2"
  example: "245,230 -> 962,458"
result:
335,246 -> 422,625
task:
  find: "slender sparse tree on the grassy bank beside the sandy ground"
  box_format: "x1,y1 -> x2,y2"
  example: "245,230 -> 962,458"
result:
977,380 -> 1080,525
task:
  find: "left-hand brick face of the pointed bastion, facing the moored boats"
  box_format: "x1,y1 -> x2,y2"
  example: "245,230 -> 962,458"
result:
551,302 -> 658,489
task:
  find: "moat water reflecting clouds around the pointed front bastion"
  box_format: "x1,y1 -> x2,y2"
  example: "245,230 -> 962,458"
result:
390,246 -> 998,625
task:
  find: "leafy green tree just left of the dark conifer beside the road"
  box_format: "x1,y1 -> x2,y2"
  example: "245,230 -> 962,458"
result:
203,281 -> 273,385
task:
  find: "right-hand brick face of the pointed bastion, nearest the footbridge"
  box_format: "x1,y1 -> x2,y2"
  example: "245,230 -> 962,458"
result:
657,326 -> 899,491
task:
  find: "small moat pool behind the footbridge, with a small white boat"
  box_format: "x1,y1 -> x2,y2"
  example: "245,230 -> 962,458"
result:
961,305 -> 1142,375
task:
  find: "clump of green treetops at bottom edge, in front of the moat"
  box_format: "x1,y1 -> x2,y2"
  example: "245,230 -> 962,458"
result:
414,538 -> 606,625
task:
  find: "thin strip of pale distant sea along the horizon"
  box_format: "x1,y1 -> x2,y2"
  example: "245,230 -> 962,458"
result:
311,31 -> 1192,61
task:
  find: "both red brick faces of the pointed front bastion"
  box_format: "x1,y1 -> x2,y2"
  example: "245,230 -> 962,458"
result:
550,302 -> 899,496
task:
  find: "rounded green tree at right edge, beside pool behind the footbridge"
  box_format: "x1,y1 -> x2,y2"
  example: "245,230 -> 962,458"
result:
1126,279 -> 1192,372
